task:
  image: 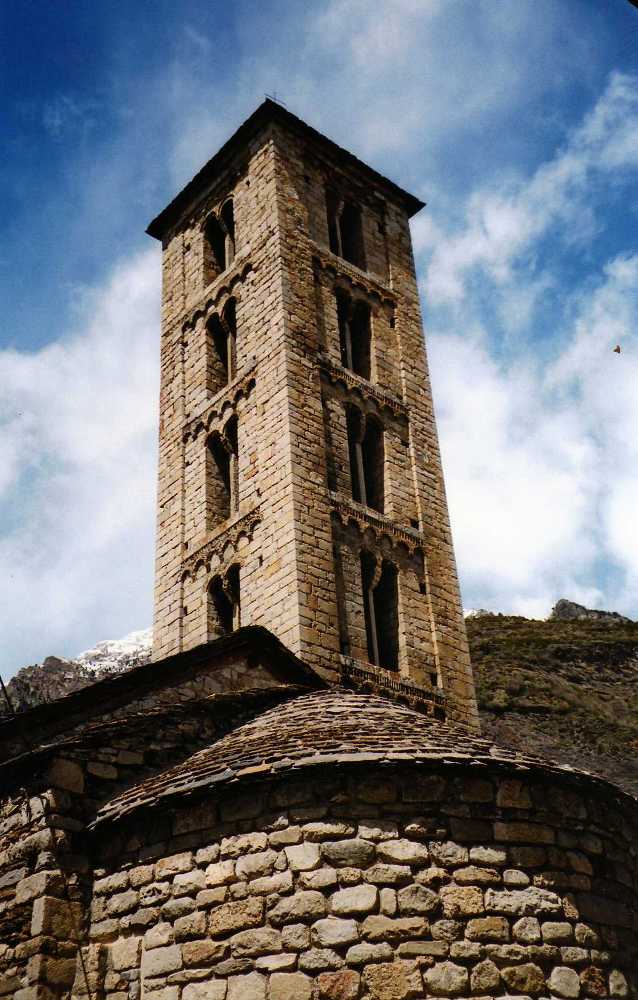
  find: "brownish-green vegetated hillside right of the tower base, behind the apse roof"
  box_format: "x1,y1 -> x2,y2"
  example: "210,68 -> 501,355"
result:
466,615 -> 638,795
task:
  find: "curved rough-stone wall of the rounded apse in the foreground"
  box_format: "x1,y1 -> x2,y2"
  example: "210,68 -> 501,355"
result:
85,765 -> 638,1000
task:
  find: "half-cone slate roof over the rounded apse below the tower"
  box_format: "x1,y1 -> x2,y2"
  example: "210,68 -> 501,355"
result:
94,688 -> 592,825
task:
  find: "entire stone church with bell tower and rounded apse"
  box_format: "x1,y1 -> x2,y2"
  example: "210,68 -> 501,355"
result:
0,100 -> 638,1000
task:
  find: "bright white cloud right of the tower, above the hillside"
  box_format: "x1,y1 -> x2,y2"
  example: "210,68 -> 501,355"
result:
429,248 -> 638,617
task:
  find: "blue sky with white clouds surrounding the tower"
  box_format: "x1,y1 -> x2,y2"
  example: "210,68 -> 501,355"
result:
0,0 -> 638,677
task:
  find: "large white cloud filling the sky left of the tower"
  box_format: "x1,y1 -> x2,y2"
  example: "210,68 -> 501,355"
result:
0,250 -> 160,671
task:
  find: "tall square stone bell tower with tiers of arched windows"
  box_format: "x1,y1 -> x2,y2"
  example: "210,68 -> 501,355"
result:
148,100 -> 477,727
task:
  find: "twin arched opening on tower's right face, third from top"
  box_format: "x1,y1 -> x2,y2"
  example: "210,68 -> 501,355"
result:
346,406 -> 385,514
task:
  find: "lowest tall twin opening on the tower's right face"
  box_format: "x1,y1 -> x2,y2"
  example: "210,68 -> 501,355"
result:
361,552 -> 399,670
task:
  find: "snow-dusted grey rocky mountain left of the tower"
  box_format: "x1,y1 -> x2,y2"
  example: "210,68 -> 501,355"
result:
0,628 -> 152,716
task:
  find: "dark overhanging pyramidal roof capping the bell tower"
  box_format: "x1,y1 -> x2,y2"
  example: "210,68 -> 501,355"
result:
146,98 -> 425,240
